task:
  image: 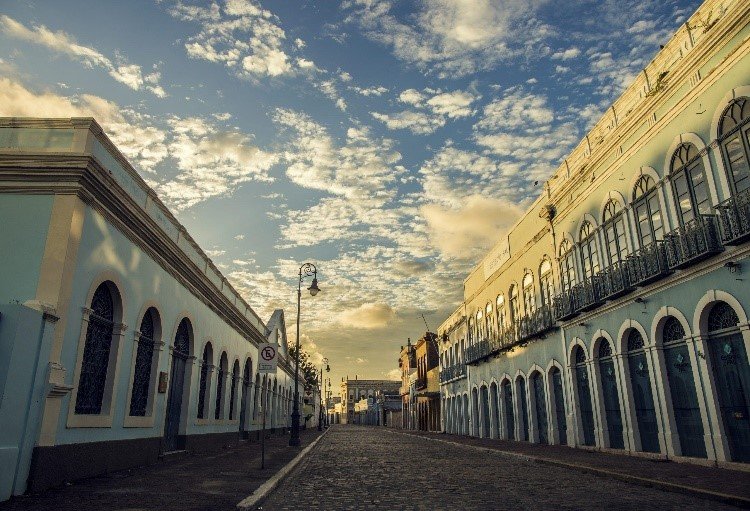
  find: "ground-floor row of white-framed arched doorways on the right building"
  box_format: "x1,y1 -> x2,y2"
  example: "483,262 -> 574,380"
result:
443,291 -> 750,462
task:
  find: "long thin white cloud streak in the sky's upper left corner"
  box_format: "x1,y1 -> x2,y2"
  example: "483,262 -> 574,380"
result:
0,15 -> 166,98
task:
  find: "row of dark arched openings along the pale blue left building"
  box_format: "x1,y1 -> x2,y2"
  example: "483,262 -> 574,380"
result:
71,280 -> 293,450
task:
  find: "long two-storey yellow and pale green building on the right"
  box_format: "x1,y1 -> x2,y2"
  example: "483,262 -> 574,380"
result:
438,0 -> 750,464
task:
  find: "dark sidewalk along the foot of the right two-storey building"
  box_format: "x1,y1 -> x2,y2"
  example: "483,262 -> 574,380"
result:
390,429 -> 750,507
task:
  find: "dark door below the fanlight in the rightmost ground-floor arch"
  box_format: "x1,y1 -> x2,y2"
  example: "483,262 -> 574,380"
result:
709,333 -> 750,463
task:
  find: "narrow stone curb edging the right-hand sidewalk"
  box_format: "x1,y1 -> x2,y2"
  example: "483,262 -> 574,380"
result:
388,430 -> 750,509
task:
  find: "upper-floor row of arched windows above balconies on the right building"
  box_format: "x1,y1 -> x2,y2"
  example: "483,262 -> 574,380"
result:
462,91 -> 750,356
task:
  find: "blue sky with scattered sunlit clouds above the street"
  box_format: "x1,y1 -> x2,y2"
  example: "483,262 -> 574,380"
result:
0,0 -> 699,392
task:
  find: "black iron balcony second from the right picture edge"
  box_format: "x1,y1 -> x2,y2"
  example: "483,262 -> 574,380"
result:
665,215 -> 724,269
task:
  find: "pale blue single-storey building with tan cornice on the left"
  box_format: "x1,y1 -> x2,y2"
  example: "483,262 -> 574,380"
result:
0,118 -> 306,500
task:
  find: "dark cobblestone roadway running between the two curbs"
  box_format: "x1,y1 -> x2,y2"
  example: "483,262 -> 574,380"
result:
259,426 -> 736,511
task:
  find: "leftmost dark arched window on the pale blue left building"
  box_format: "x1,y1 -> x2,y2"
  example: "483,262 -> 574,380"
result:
75,282 -> 115,415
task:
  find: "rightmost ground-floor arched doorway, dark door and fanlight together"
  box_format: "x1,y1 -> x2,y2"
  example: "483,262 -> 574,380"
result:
708,302 -> 750,463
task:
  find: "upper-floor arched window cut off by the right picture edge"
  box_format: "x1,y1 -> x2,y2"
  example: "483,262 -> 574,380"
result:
719,98 -> 750,194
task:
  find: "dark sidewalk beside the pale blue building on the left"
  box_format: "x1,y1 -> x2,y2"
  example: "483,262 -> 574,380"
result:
0,429 -> 321,511
